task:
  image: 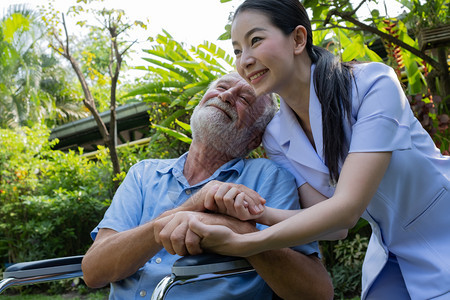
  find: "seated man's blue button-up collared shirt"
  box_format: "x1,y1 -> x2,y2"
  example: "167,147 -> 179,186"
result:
91,154 -> 319,300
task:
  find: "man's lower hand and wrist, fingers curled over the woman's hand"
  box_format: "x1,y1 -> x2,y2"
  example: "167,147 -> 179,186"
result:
154,211 -> 257,255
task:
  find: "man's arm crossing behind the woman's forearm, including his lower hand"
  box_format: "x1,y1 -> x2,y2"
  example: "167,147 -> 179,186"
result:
154,212 -> 333,299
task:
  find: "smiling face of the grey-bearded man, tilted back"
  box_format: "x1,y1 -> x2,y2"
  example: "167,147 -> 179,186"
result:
191,74 -> 265,157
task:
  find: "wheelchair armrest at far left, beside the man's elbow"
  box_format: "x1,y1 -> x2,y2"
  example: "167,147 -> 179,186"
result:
0,255 -> 83,293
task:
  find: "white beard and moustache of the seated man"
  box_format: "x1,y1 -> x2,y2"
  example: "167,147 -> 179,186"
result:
191,98 -> 252,158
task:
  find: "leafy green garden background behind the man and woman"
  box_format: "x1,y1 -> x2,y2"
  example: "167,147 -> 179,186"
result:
0,0 -> 450,299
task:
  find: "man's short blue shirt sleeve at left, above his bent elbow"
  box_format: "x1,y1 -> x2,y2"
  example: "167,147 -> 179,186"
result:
91,163 -> 143,240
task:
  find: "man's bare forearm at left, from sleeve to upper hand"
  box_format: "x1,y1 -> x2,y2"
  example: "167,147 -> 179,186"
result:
82,182 -> 263,288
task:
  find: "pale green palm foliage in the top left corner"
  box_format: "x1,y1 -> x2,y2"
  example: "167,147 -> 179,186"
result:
0,5 -> 83,128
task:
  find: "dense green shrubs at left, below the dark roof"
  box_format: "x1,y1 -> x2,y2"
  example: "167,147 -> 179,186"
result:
0,126 -> 112,262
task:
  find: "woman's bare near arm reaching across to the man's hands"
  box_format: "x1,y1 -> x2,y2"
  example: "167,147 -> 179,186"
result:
190,152 -> 391,256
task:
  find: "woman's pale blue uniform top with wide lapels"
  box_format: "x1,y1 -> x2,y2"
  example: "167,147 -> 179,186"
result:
263,63 -> 450,299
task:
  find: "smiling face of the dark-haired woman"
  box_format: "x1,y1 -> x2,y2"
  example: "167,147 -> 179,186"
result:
231,10 -> 295,96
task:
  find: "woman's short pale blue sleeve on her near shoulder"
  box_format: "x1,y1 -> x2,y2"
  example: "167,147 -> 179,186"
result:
349,63 -> 412,152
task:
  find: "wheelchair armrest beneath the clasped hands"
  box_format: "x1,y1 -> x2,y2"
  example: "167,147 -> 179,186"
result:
172,253 -> 253,276
